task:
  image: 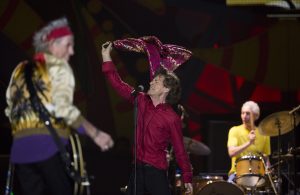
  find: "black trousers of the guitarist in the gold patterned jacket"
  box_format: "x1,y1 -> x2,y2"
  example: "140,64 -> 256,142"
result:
15,154 -> 73,195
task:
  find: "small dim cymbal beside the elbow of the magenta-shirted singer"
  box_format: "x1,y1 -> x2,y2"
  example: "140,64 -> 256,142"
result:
183,137 -> 210,155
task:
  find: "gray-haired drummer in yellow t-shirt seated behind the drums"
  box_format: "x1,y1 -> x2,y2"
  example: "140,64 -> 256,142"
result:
227,101 -> 271,182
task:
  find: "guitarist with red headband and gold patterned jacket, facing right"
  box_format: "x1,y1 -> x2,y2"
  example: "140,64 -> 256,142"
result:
5,18 -> 114,195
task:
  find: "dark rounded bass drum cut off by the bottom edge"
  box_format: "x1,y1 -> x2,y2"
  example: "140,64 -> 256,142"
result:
194,181 -> 244,195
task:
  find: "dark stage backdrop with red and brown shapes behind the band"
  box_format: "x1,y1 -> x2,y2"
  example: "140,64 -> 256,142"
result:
0,0 -> 300,194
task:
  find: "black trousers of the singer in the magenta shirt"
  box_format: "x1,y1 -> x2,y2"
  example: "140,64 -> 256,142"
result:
127,164 -> 171,195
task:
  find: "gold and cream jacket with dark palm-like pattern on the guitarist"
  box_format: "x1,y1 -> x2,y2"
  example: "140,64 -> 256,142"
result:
5,53 -> 82,139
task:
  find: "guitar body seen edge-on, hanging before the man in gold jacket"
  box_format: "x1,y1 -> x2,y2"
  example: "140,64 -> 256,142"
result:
69,133 -> 90,195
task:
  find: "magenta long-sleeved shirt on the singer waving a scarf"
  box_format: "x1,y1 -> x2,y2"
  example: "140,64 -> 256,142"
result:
102,62 -> 193,183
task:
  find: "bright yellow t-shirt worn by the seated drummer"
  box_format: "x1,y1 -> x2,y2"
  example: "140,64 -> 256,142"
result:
227,125 -> 271,175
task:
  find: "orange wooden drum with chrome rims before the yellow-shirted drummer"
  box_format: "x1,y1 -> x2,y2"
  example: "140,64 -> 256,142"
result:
235,156 -> 266,188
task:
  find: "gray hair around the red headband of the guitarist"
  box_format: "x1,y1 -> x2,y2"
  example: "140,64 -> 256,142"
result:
33,17 -> 69,52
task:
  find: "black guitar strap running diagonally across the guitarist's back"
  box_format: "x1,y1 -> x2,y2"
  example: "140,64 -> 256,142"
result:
25,62 -> 83,182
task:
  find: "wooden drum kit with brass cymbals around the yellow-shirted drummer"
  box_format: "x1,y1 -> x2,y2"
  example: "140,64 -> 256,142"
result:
176,106 -> 300,195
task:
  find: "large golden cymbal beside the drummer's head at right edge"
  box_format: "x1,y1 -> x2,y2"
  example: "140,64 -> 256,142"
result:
258,111 -> 300,136
